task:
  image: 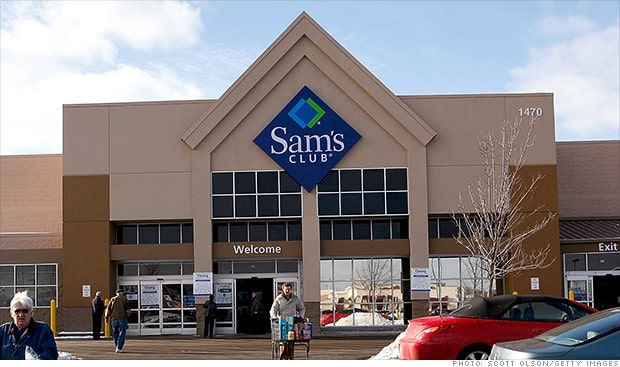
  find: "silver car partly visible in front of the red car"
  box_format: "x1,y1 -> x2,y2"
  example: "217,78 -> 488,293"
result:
489,307 -> 620,360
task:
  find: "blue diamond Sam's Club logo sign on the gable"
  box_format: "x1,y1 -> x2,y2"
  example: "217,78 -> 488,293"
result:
254,86 -> 362,192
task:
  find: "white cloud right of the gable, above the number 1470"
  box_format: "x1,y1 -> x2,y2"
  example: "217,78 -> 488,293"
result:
508,18 -> 620,141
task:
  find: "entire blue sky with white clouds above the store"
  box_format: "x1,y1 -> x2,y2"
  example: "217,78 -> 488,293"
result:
0,0 -> 620,154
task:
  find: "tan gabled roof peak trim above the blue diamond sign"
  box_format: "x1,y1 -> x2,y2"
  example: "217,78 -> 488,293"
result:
182,11 -> 436,151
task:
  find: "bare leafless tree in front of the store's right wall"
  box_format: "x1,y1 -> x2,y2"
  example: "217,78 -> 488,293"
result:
452,118 -> 555,295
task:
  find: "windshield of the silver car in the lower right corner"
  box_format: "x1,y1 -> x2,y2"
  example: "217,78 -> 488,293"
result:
535,308 -> 620,346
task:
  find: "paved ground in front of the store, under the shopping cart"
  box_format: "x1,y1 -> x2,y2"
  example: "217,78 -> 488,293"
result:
56,334 -> 398,360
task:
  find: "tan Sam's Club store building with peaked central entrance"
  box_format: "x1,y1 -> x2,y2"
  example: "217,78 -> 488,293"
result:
0,13 -> 620,335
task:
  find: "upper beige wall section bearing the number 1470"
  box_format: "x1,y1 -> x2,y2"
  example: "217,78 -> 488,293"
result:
401,93 -> 556,214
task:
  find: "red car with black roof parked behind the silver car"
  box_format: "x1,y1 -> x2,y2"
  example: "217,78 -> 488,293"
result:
398,295 -> 597,360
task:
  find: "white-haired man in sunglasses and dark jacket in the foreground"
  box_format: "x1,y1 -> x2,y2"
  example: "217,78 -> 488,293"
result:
0,291 -> 58,359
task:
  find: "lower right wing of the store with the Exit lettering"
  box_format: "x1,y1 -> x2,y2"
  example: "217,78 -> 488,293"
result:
557,141 -> 620,309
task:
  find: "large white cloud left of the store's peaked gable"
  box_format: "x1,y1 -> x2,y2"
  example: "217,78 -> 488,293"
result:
0,1 -> 207,154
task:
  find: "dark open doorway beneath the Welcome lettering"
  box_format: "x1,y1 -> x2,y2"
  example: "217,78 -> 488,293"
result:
235,277 -> 274,334
